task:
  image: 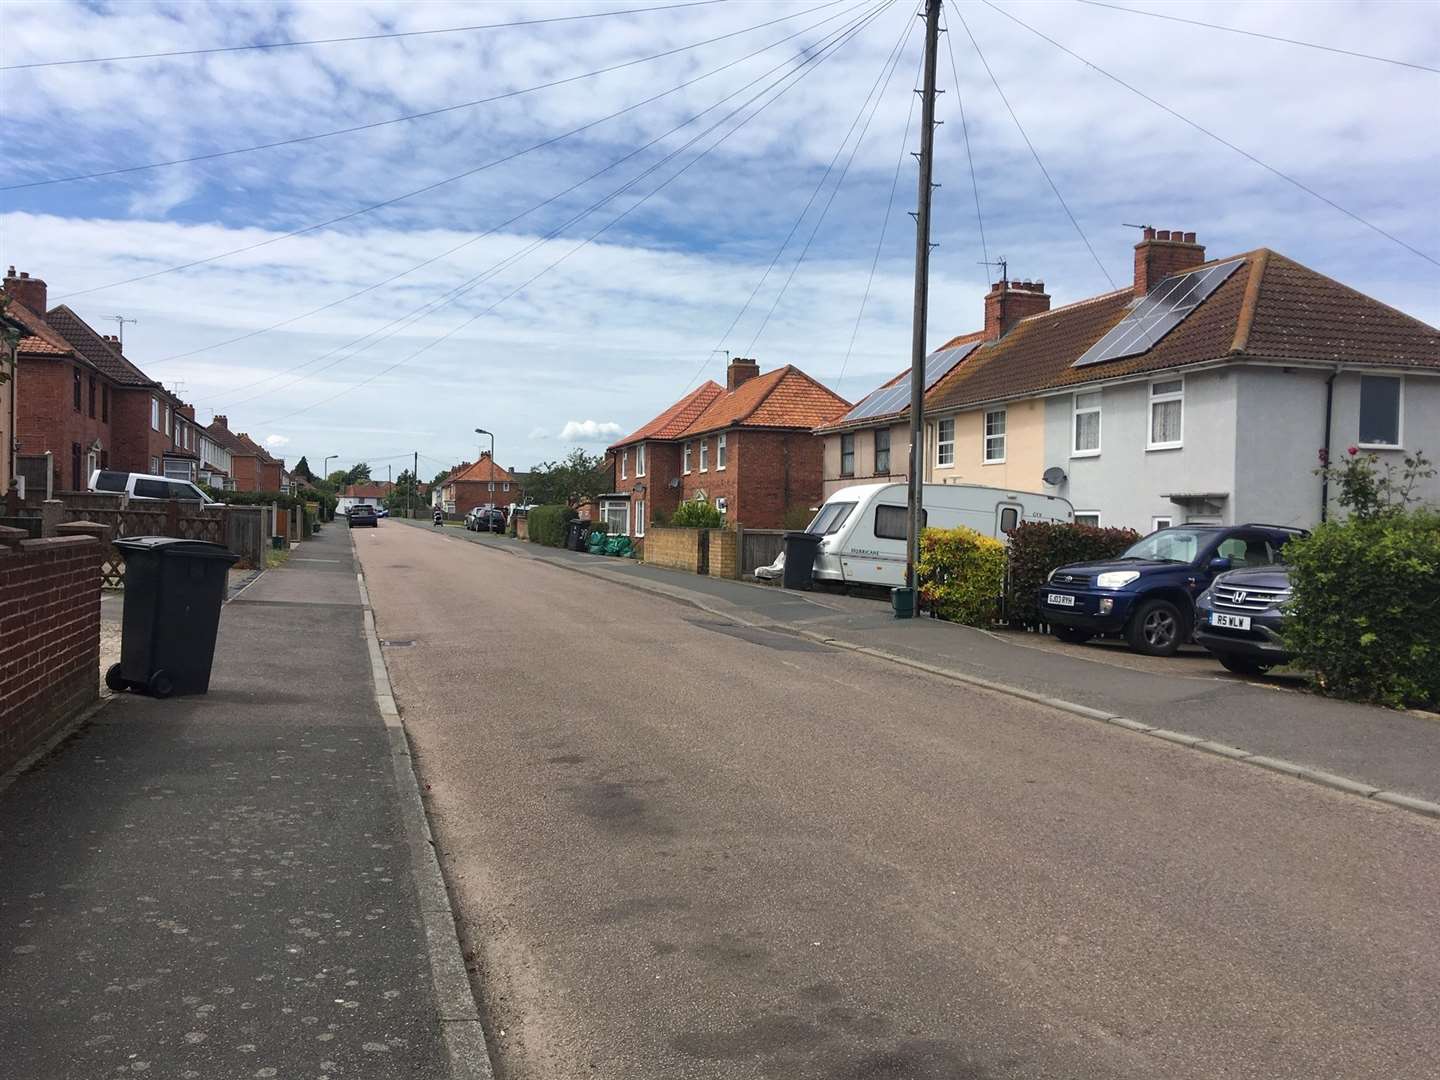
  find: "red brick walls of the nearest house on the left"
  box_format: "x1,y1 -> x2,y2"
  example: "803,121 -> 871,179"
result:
16,359 -> 115,491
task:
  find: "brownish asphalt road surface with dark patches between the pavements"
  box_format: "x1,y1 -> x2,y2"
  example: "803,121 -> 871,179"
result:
354,527 -> 1440,1080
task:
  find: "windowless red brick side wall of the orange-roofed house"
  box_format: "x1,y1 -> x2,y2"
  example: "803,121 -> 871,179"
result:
737,431 -> 825,528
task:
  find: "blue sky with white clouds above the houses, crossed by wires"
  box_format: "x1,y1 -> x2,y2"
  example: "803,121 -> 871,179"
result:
0,0 -> 1440,474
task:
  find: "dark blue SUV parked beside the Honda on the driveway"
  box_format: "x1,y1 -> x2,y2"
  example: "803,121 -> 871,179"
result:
1037,524 -> 1305,657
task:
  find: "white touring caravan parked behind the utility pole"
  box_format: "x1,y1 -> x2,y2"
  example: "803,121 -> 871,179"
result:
755,484 -> 1076,588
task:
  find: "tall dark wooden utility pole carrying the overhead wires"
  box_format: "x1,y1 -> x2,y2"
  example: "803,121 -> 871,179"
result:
896,0 -> 940,618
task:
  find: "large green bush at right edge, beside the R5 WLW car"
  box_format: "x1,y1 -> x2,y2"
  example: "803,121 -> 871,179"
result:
1284,510 -> 1440,706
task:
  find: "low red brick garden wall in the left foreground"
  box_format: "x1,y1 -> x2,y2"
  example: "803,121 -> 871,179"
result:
0,536 -> 102,772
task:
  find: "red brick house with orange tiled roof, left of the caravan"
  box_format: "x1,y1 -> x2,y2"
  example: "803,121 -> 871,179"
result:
600,357 -> 850,539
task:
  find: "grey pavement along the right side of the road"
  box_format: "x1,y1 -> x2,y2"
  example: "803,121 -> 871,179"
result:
416,523 -> 1440,801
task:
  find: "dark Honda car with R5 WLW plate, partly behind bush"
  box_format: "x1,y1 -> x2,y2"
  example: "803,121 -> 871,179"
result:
1195,566 -> 1290,675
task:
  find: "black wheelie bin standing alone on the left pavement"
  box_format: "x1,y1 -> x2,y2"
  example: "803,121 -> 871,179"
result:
105,536 -> 239,697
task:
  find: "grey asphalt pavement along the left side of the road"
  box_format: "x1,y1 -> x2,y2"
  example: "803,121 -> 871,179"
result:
0,526 -> 463,1080
